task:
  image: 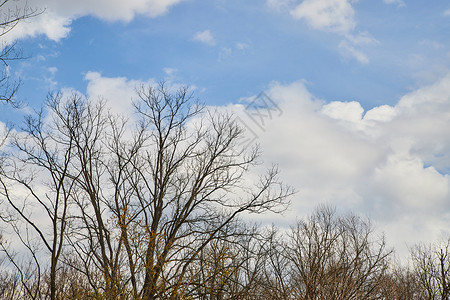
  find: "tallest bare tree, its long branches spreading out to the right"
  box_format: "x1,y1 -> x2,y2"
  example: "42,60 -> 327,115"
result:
121,85 -> 292,299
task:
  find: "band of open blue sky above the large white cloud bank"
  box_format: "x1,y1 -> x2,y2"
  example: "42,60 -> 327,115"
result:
4,0 -> 450,113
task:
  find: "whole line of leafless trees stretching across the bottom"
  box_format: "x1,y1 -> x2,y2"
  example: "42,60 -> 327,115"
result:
0,84 -> 450,300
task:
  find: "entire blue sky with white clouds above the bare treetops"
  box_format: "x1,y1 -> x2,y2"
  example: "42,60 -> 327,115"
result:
0,0 -> 450,255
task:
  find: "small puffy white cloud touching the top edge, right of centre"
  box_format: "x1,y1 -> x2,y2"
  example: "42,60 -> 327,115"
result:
291,0 -> 356,34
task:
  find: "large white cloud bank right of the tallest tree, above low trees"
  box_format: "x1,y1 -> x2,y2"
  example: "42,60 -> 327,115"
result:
232,75 -> 450,255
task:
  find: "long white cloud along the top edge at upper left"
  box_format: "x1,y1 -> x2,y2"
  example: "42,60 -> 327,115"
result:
2,0 -> 182,41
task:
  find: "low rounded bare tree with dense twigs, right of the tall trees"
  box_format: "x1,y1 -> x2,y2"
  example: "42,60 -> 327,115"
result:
258,206 -> 391,299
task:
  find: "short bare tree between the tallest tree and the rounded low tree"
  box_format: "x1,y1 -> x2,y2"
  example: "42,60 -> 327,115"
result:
183,222 -> 267,299
